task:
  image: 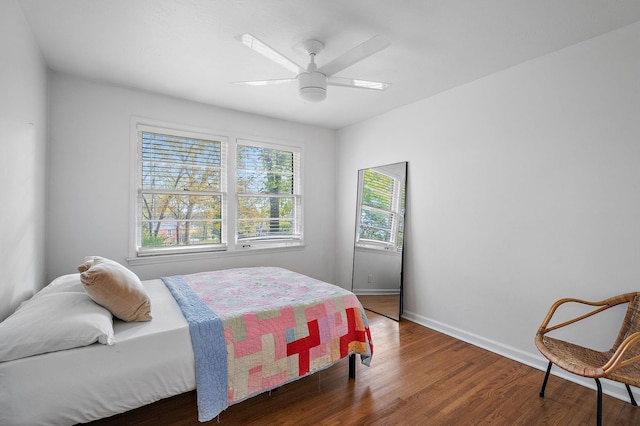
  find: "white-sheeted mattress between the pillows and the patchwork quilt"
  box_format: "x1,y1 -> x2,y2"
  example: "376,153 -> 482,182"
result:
0,280 -> 196,425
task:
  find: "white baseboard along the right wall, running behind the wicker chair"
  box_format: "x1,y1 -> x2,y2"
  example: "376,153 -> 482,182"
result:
402,310 -> 640,405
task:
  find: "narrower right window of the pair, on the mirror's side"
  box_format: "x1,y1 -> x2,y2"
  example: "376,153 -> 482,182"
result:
236,140 -> 302,247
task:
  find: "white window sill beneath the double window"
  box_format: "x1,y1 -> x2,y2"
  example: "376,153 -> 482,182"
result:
127,243 -> 304,266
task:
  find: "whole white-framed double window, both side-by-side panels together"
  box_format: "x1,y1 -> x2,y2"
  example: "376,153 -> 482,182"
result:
130,120 -> 302,260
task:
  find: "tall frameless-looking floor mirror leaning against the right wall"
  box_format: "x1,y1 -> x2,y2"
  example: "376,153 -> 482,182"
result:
352,162 -> 407,321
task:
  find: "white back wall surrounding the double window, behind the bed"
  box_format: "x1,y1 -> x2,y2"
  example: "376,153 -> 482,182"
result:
47,73 -> 335,282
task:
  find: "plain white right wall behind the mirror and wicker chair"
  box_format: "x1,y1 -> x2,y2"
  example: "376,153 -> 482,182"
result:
336,23 -> 640,376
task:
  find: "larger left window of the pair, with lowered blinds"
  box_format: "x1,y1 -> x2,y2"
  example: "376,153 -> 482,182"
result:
136,127 -> 226,255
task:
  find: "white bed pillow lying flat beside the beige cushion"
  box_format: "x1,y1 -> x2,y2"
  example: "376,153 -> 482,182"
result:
0,274 -> 114,362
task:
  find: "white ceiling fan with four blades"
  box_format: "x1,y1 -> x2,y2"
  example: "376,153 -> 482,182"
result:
234,33 -> 391,102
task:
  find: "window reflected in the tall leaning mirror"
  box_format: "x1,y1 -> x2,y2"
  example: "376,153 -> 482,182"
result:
356,169 -> 405,251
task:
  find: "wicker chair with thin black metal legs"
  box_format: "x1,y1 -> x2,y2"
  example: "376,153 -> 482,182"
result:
535,292 -> 640,426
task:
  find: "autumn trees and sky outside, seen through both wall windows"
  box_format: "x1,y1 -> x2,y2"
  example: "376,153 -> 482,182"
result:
139,132 -> 298,247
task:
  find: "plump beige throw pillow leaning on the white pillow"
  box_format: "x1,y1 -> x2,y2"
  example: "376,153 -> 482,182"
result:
78,256 -> 151,321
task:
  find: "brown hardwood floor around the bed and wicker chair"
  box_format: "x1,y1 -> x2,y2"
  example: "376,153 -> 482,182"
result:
86,313 -> 640,426
